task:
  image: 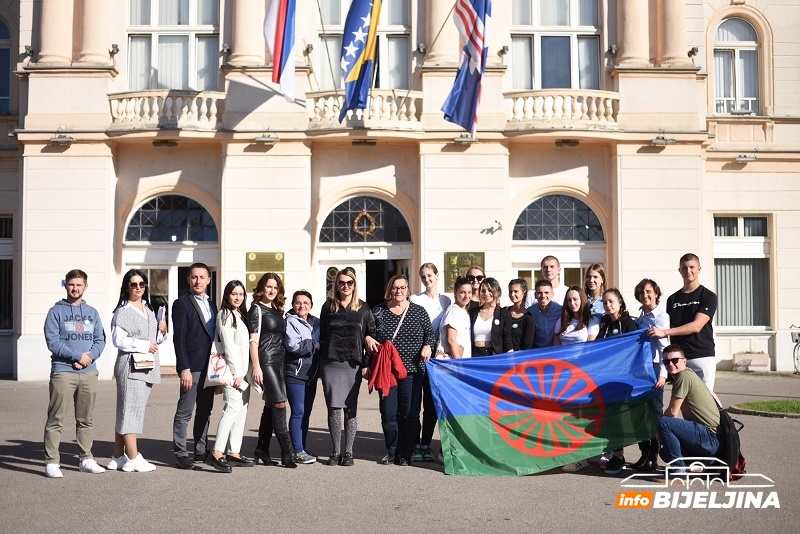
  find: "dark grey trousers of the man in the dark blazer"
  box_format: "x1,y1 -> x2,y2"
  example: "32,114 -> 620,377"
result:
172,371 -> 215,457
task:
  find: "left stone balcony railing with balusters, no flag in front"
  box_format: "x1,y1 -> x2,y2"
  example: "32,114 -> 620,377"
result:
108,89 -> 225,130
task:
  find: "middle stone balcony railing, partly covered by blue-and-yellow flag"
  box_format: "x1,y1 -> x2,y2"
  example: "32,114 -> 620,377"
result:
306,89 -> 422,130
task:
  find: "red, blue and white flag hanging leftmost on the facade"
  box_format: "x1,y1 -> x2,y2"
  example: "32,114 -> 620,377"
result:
264,0 -> 295,102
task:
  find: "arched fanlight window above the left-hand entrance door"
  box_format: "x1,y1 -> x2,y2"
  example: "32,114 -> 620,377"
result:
125,195 -> 218,243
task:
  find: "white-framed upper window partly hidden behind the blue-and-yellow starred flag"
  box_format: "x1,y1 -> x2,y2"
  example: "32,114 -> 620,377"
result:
315,0 -> 411,90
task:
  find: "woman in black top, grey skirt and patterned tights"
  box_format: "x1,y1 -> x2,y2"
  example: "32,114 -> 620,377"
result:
319,267 -> 378,466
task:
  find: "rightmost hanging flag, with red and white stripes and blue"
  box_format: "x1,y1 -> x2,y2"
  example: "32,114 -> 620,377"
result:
442,0 -> 492,137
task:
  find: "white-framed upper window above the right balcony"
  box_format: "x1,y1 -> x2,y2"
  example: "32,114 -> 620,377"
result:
511,0 -> 601,90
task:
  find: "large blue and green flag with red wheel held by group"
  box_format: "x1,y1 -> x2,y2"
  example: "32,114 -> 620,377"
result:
427,330 -> 658,475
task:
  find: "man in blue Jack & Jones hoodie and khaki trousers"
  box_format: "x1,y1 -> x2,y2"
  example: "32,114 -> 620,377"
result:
44,269 -> 106,478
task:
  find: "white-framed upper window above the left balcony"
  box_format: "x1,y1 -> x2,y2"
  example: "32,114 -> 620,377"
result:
128,0 -> 219,91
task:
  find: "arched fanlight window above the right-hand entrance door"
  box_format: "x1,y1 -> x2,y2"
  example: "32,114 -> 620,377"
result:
514,195 -> 605,241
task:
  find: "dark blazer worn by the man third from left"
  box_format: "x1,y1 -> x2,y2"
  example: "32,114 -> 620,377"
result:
172,293 -> 217,374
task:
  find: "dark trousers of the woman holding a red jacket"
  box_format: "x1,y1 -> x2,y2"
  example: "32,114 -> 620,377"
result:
380,373 -> 425,460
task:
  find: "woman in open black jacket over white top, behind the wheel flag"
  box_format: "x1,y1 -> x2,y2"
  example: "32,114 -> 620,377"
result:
469,278 -> 514,358
